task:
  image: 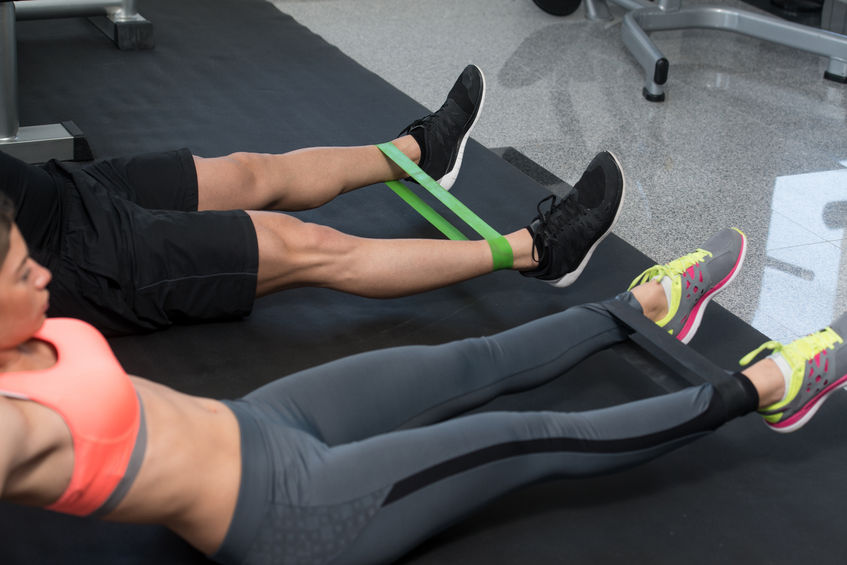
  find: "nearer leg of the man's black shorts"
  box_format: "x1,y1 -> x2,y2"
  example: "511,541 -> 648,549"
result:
50,202 -> 258,335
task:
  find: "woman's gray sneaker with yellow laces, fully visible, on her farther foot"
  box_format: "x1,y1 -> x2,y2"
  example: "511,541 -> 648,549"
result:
629,228 -> 747,343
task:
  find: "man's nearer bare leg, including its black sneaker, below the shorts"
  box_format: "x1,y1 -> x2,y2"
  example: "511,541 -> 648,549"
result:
248,149 -> 625,298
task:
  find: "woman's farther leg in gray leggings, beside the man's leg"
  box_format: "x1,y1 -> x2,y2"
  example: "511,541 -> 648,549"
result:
246,285 -> 648,445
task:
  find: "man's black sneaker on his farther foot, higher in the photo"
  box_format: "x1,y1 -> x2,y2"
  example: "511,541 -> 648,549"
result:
398,65 -> 485,190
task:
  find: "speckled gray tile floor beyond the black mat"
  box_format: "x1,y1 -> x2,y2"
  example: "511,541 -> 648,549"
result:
274,0 -> 847,341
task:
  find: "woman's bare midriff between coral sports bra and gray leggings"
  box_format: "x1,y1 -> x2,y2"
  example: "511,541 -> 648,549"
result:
106,377 -> 241,555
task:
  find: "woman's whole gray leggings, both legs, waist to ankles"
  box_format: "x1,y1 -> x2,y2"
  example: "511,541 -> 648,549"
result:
212,293 -> 756,564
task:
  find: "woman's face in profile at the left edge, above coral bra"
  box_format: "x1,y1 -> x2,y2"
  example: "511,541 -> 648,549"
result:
0,224 -> 51,348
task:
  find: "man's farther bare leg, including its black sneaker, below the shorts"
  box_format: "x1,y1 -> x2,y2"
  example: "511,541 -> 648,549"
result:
195,65 -> 485,210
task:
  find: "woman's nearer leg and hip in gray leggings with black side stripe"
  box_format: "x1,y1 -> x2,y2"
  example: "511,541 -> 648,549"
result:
222,362 -> 756,564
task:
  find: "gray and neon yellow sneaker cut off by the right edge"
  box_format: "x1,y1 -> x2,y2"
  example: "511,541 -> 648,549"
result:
741,314 -> 847,433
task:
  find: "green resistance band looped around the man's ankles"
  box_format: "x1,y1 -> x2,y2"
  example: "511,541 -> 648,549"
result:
377,142 -> 514,271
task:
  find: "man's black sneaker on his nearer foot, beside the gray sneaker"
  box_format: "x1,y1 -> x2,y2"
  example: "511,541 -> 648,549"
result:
521,152 -> 626,287
